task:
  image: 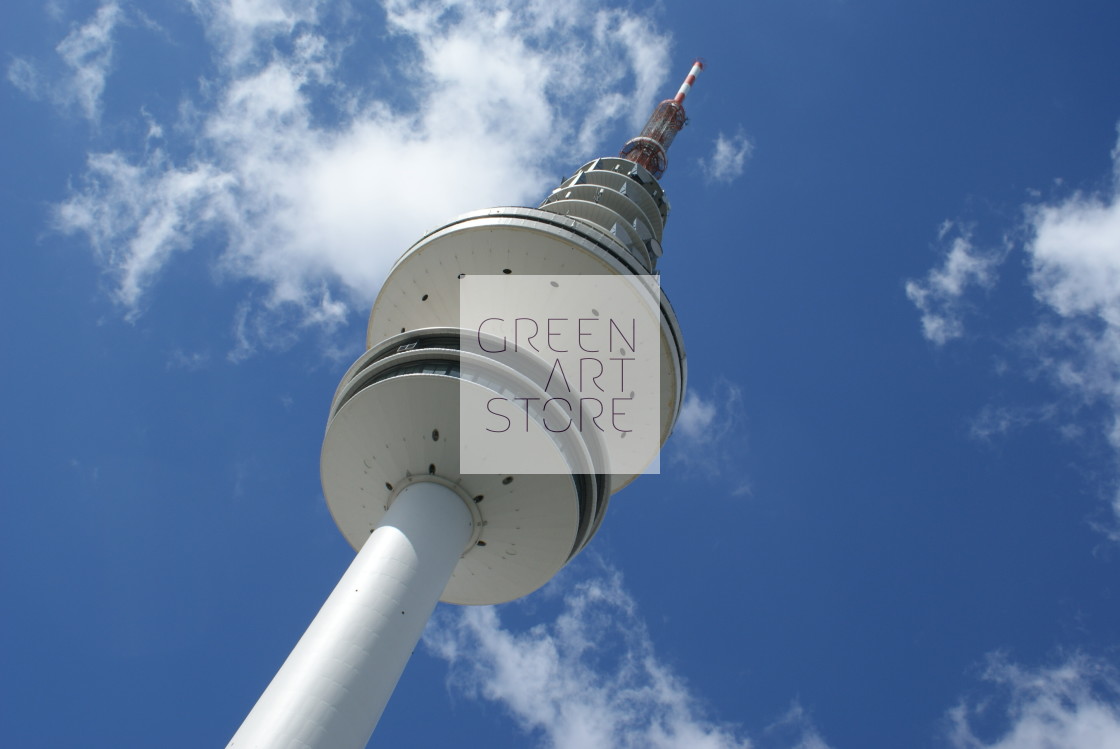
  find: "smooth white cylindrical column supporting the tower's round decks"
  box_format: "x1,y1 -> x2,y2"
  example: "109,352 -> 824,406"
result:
227,481 -> 473,749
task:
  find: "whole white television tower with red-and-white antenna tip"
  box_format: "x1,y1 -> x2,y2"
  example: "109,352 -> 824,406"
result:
228,60 -> 702,749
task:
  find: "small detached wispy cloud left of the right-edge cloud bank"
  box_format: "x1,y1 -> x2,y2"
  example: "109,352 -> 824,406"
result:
906,222 -> 1005,346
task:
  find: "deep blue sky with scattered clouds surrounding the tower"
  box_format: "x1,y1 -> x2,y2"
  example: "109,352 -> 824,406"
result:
0,0 -> 1120,749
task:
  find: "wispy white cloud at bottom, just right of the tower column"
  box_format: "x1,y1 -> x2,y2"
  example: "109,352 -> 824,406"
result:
424,570 -> 827,749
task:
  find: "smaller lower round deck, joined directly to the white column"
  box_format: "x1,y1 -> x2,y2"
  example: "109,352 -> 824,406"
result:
320,328 -> 610,603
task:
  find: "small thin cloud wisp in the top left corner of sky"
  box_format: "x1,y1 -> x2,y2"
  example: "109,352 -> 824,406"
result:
8,2 -> 123,122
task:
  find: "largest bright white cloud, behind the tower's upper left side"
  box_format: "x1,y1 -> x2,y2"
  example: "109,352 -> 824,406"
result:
43,0 -> 668,358
